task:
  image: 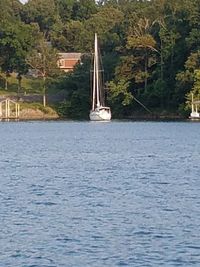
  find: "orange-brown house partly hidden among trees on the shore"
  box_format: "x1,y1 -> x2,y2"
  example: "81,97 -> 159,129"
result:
58,53 -> 82,72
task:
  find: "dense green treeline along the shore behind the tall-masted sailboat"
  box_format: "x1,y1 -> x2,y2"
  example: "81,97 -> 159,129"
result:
0,0 -> 200,117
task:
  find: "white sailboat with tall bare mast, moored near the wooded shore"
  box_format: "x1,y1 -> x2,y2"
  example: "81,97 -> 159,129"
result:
90,33 -> 111,121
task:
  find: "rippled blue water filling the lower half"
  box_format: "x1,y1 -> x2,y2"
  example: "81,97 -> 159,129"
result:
0,122 -> 200,267
